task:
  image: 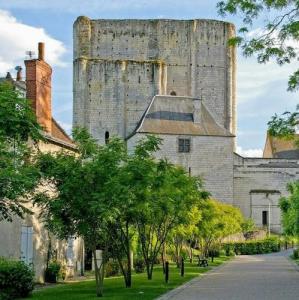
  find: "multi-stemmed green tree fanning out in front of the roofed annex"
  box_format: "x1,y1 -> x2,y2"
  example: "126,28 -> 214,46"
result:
128,136 -> 206,279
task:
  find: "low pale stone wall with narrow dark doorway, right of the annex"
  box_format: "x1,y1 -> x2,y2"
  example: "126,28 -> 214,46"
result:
234,155 -> 299,232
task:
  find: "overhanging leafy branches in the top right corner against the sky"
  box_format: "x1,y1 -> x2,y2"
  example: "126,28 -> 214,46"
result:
217,0 -> 299,91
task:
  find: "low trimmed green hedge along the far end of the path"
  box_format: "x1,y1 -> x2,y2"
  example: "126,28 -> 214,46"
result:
223,238 -> 280,255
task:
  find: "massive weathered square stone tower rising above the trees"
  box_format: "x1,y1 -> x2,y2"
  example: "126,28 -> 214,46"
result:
73,17 -> 236,143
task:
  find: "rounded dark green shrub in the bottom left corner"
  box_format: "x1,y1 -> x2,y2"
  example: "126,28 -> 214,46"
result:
0,257 -> 34,300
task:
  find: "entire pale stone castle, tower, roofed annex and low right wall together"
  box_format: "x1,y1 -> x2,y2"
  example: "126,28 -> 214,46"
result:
73,17 -> 298,231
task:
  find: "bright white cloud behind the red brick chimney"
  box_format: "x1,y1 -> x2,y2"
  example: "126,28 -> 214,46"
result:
0,10 -> 66,75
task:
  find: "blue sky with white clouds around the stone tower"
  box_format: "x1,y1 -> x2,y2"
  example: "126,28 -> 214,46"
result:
0,0 -> 298,155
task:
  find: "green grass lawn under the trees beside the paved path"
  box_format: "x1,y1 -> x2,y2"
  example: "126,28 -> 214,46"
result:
30,257 -> 229,300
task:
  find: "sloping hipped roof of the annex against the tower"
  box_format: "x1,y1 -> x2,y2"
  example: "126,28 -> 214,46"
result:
135,95 -> 233,136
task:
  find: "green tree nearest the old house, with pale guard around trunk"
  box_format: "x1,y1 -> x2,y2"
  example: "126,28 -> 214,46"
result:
35,129 -> 126,297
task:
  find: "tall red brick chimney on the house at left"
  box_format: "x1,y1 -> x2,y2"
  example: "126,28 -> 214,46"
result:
25,43 -> 52,133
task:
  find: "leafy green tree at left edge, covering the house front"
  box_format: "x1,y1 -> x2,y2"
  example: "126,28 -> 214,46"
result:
0,83 -> 42,221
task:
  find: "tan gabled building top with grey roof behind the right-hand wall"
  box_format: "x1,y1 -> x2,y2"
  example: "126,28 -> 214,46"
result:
263,133 -> 299,159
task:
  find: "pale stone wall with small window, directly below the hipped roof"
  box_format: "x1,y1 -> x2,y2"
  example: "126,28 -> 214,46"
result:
128,133 -> 234,204
